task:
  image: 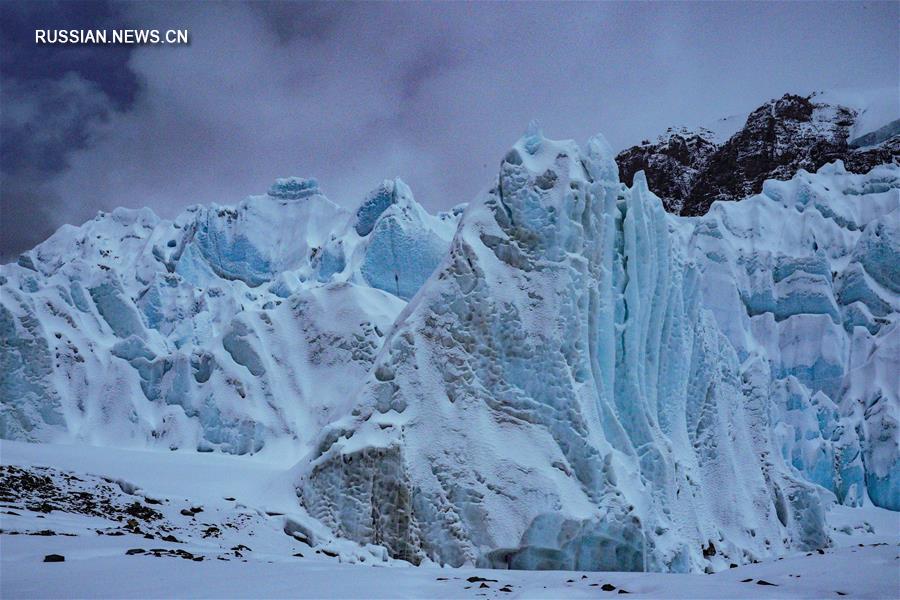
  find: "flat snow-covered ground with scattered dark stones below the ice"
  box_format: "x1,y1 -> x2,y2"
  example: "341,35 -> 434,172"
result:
0,441 -> 900,598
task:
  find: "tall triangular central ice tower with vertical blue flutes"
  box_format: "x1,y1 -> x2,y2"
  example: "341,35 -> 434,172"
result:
296,132 -> 828,571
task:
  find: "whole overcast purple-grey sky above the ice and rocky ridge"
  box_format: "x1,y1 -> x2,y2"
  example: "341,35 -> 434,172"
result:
0,1 -> 900,262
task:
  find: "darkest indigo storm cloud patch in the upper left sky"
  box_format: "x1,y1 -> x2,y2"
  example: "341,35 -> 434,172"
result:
0,2 -> 138,262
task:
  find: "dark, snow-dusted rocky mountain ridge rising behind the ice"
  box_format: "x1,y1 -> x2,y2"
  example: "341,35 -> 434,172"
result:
616,94 -> 900,215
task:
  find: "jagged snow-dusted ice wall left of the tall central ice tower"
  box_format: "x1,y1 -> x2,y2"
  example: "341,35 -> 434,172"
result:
0,178 -> 442,453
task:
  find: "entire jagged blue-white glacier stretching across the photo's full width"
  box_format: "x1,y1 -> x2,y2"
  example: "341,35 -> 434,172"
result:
0,126 -> 900,572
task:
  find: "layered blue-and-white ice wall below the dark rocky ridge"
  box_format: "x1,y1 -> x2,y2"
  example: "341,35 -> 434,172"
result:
680,162 -> 900,510
